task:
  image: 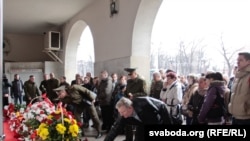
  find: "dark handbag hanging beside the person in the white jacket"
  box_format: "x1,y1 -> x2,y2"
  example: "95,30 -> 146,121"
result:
170,99 -> 183,125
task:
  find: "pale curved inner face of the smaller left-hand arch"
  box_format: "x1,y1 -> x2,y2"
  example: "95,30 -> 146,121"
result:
64,20 -> 87,80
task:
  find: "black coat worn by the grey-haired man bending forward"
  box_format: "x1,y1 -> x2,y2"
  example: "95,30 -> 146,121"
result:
104,96 -> 172,141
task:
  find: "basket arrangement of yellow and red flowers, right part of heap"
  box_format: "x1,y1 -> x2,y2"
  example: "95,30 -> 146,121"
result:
37,102 -> 80,141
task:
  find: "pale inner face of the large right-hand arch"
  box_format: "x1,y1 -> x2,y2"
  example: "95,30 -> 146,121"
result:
130,0 -> 163,81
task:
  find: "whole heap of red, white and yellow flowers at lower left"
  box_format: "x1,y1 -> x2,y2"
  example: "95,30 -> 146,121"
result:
5,95 -> 81,141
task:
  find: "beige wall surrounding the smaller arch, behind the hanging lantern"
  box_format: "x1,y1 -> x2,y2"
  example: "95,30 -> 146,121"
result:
63,0 -> 143,81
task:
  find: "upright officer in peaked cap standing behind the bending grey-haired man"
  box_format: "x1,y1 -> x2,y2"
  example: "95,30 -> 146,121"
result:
124,68 -> 147,141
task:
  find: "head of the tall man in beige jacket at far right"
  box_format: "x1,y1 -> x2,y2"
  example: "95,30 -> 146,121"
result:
237,52 -> 250,71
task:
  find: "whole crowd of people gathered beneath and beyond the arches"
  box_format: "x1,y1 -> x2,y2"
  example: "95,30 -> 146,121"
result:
3,52 -> 250,141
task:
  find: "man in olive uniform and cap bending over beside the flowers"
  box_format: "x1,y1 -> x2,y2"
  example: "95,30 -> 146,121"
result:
54,85 -> 102,138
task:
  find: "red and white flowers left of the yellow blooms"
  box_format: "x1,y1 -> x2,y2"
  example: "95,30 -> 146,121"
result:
9,95 -> 55,140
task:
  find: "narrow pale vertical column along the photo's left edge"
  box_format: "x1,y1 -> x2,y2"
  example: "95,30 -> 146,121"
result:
0,0 -> 5,141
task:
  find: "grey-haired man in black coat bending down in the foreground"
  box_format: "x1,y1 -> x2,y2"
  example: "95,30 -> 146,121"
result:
104,96 -> 172,141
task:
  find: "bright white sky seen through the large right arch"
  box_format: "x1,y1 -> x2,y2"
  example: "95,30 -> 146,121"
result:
152,0 -> 250,66
